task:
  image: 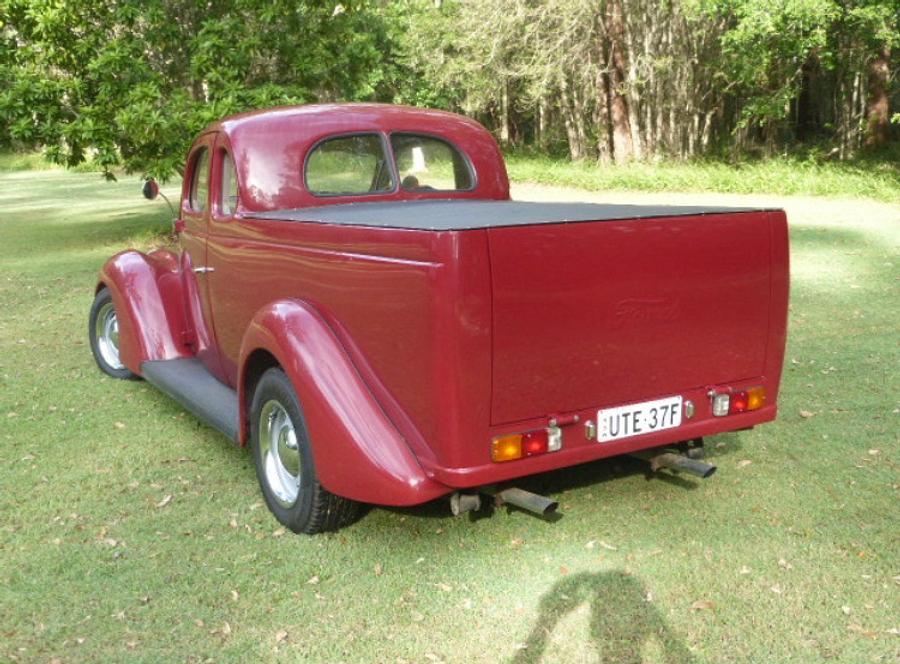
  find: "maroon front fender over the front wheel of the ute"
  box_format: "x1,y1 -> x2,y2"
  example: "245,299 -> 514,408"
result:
97,250 -> 190,374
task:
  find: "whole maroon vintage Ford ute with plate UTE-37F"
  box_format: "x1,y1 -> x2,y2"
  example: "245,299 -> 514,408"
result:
89,104 -> 788,533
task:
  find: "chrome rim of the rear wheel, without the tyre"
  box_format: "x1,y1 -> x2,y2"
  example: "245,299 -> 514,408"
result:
259,399 -> 300,507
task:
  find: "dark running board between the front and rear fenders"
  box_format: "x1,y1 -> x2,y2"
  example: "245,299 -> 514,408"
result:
141,358 -> 239,442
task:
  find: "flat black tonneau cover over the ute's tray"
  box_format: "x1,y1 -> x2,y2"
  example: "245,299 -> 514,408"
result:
244,199 -> 772,231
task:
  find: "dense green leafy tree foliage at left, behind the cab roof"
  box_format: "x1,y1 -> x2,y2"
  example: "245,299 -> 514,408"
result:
0,0 -> 394,178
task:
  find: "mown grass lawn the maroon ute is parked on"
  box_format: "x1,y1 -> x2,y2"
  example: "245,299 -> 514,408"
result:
0,164 -> 900,664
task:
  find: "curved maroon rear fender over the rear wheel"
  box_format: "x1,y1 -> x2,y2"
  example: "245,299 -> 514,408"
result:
238,300 -> 450,505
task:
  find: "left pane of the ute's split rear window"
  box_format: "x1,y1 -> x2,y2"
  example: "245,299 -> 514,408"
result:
306,134 -> 394,196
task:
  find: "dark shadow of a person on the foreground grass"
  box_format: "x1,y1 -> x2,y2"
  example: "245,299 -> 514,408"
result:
510,570 -> 694,664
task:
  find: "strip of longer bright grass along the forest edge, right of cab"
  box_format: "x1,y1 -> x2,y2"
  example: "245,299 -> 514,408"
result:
507,153 -> 900,203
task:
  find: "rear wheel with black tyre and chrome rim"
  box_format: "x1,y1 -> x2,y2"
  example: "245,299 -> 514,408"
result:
250,368 -> 359,535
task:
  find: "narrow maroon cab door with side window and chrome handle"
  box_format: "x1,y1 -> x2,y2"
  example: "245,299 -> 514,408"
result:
179,132 -> 225,381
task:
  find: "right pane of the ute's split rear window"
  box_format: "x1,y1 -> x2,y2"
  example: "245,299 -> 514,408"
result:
391,134 -> 475,191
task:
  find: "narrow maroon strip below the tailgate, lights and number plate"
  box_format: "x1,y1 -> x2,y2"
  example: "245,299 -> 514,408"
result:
429,404 -> 777,489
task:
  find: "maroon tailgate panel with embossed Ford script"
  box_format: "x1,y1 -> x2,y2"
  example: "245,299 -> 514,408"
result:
488,212 -> 770,424
